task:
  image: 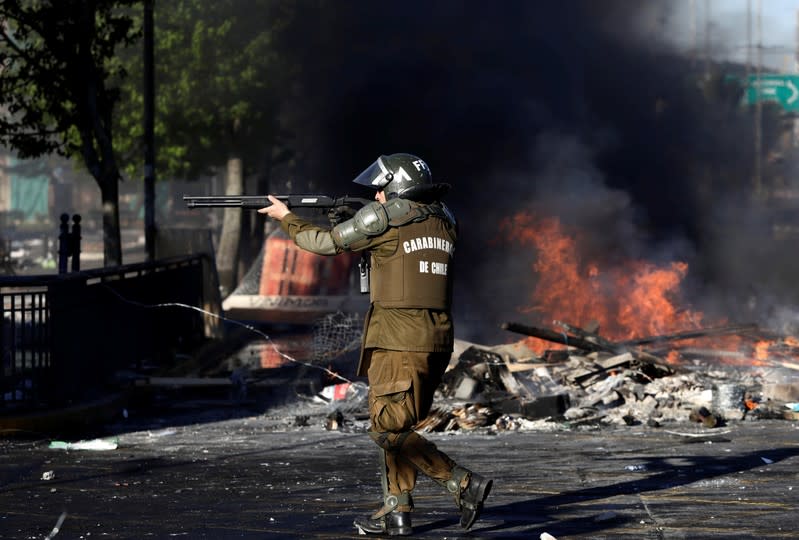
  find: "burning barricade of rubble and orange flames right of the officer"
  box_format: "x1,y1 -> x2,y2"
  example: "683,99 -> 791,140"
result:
390,212 -> 799,431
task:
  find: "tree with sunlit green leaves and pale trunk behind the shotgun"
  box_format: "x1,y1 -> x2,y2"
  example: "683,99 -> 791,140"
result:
117,0 -> 291,294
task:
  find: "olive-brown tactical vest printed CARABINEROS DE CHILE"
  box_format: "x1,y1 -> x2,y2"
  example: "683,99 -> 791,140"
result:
370,206 -> 456,310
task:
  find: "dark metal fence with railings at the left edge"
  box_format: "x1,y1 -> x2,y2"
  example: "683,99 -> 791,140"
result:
0,255 -> 208,415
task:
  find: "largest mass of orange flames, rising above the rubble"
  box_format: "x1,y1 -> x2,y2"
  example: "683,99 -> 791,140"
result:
502,213 -> 720,358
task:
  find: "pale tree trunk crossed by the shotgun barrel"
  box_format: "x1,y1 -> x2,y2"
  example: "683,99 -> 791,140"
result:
216,156 -> 244,298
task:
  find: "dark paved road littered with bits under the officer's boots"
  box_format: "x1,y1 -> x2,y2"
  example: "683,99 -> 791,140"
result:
0,398 -> 799,540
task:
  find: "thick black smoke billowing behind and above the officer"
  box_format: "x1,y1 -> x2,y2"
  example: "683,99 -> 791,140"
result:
280,0 -> 796,340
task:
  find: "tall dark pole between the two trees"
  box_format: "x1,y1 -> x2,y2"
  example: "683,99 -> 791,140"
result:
143,0 -> 155,261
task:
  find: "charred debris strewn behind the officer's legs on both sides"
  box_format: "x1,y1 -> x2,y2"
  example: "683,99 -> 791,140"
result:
133,321 -> 799,432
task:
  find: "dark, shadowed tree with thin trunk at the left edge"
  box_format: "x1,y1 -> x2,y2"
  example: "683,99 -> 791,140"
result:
0,0 -> 140,266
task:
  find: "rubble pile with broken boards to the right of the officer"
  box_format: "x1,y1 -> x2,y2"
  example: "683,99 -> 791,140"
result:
417,322 -> 799,431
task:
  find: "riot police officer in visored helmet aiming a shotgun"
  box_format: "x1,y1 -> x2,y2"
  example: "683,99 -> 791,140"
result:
259,154 -> 492,536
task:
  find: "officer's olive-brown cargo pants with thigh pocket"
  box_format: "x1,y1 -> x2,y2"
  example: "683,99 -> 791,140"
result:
368,349 -> 456,512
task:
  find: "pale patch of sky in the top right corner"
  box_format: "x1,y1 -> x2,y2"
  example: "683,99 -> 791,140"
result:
668,0 -> 799,72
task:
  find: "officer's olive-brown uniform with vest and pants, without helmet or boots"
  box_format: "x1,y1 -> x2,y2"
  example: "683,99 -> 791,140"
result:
281,203 -> 457,512
